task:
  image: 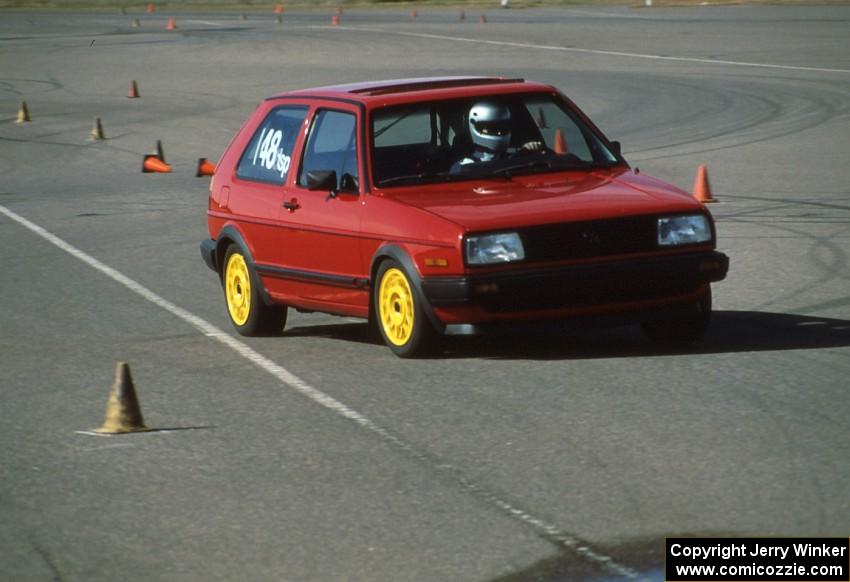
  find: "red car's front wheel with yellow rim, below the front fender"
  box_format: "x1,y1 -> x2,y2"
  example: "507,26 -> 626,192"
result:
372,259 -> 439,358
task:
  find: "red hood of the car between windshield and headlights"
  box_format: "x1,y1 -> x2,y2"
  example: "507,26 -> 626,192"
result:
379,170 -> 702,231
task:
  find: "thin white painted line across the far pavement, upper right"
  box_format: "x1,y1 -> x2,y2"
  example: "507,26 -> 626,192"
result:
318,26 -> 850,73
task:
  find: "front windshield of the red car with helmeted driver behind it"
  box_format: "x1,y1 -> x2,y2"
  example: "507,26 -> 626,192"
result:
371,93 -> 620,187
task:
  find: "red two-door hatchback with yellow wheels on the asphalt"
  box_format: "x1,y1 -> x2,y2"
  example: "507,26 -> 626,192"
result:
201,77 -> 729,357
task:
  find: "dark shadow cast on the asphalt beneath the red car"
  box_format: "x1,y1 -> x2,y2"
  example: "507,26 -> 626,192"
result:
284,311 -> 850,360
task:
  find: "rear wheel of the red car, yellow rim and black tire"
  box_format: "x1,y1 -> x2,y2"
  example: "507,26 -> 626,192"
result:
221,244 -> 286,336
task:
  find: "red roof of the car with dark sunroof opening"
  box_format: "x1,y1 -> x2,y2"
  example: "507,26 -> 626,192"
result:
269,77 -> 555,107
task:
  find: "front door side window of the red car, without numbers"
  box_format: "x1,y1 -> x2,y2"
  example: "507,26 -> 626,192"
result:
298,109 -> 360,192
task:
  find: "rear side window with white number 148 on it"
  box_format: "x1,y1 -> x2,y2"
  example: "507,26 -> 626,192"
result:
236,105 -> 308,184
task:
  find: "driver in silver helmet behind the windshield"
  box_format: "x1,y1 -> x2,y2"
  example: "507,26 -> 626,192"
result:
451,101 -> 543,173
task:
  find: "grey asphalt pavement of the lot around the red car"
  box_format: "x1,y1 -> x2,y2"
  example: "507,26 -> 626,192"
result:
0,6 -> 850,581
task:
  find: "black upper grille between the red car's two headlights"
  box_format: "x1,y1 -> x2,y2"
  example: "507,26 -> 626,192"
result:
520,216 -> 657,262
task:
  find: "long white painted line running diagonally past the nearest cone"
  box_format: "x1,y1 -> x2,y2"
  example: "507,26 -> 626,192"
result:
0,205 -> 640,579
